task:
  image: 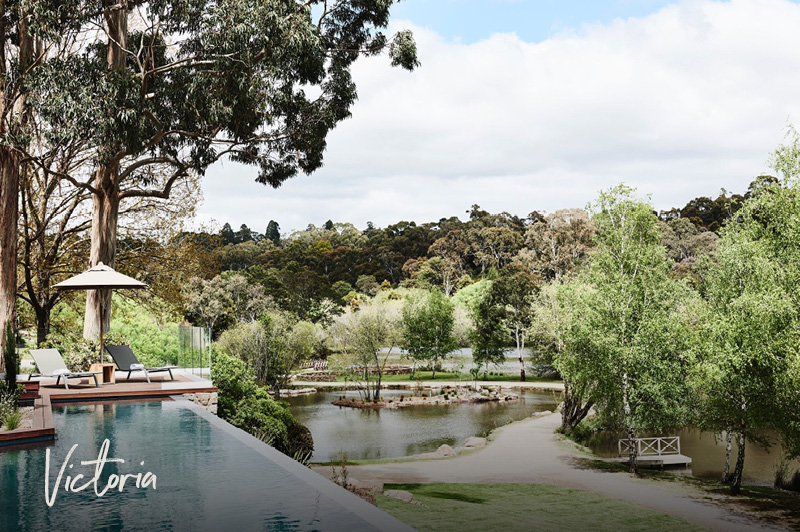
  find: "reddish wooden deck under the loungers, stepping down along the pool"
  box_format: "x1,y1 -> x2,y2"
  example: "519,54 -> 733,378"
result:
0,371 -> 217,447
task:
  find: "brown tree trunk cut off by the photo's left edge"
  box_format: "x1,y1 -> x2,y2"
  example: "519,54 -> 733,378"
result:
0,146 -> 19,372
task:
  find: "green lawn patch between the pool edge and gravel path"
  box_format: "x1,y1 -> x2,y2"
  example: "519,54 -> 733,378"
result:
375,484 -> 704,532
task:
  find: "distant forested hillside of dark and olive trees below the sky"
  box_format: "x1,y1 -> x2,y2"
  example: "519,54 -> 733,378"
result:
179,176 -> 775,328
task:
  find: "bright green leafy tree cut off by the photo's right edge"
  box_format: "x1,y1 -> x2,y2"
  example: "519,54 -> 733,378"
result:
699,157 -> 800,492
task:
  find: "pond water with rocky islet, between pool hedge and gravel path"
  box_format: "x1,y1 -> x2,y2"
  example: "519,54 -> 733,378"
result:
289,390 -> 561,462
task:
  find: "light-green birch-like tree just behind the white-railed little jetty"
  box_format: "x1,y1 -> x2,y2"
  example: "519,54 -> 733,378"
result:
557,185 -> 698,473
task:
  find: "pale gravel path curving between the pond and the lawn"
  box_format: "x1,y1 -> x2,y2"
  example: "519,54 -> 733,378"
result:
315,414 -> 788,532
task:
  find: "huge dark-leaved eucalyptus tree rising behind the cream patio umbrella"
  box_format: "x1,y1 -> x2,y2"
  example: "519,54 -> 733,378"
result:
29,0 -> 418,342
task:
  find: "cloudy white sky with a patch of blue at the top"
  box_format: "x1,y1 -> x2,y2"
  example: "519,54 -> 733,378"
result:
197,0 -> 800,232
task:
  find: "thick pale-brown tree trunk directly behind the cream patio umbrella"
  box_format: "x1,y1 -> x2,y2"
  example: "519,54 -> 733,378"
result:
83,0 -> 128,340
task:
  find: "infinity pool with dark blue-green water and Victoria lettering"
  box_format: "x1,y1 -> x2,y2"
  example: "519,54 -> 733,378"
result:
0,401 -> 411,532
